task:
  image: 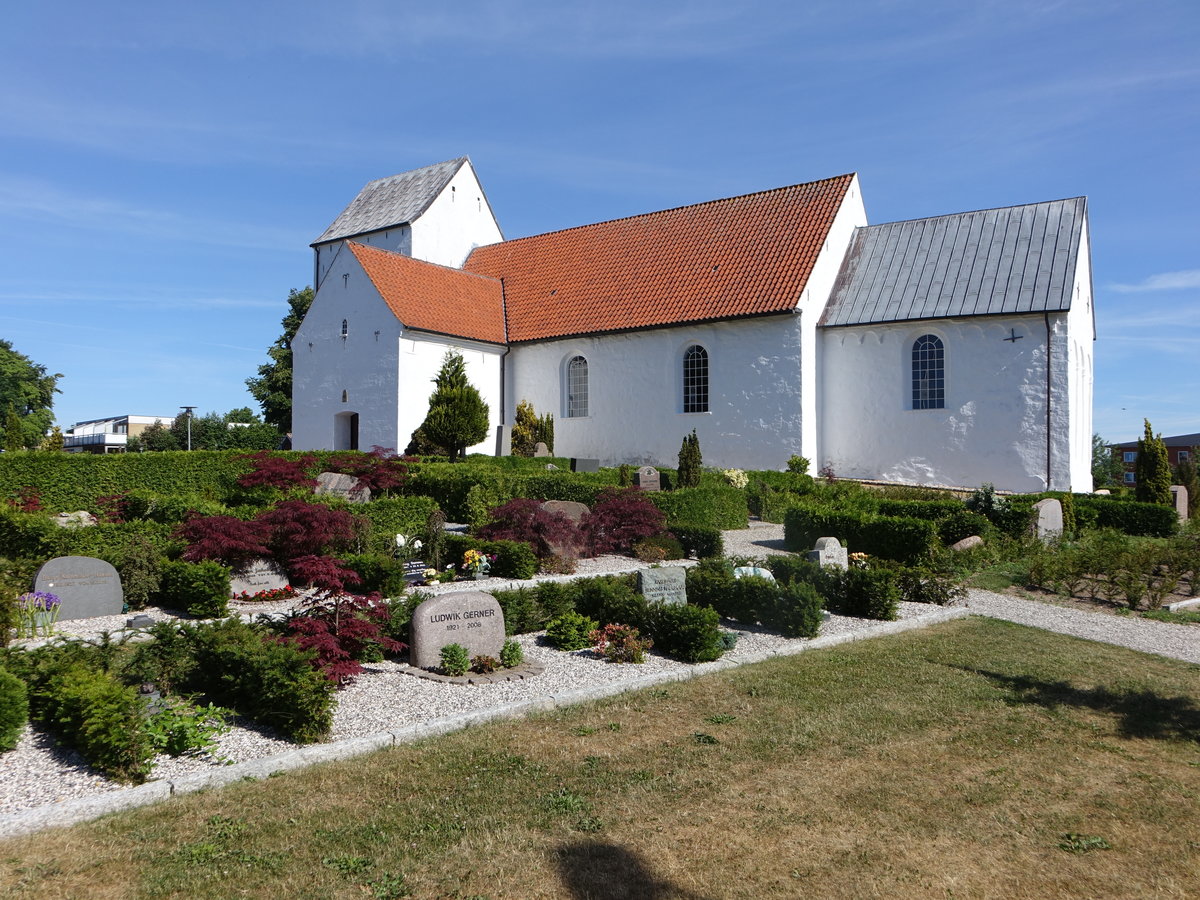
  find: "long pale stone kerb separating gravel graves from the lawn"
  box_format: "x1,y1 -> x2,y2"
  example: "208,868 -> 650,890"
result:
0,607 -> 972,838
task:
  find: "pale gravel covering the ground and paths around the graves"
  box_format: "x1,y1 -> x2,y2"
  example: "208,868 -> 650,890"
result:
0,523 -> 1200,830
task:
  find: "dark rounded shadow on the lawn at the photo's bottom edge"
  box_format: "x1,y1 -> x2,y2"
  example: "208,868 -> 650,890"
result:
556,841 -> 707,900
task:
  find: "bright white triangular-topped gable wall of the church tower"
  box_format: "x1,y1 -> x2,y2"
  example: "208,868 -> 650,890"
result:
410,163 -> 504,269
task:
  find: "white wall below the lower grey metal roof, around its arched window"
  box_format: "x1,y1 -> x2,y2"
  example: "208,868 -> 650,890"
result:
814,316 -> 1067,492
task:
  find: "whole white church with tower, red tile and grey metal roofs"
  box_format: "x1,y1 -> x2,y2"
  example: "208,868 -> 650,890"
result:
293,158 -> 1096,491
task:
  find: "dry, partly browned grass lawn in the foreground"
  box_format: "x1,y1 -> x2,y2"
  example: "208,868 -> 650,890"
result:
0,618 -> 1200,900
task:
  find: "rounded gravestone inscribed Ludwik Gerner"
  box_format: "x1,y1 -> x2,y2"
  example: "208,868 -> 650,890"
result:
408,590 -> 504,668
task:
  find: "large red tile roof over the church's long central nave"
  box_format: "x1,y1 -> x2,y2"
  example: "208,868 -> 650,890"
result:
460,175 -> 853,342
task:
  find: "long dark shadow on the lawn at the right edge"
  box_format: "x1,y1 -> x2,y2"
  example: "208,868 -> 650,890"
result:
956,666 -> 1200,740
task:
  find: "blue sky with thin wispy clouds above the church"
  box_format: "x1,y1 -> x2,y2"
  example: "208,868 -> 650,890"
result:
0,0 -> 1200,440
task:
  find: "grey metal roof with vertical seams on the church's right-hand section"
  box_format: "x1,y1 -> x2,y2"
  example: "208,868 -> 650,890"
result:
821,197 -> 1087,326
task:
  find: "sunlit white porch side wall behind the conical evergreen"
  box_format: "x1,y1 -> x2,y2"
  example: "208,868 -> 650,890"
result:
396,331 -> 504,454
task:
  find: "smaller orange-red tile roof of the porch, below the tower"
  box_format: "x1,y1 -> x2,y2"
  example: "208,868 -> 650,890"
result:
346,241 -> 504,343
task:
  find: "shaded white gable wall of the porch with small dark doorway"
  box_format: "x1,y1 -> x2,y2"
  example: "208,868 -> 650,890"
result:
292,252 -> 401,450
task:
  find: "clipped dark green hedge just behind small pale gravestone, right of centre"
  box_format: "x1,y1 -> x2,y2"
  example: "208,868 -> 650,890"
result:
784,504 -> 938,563
